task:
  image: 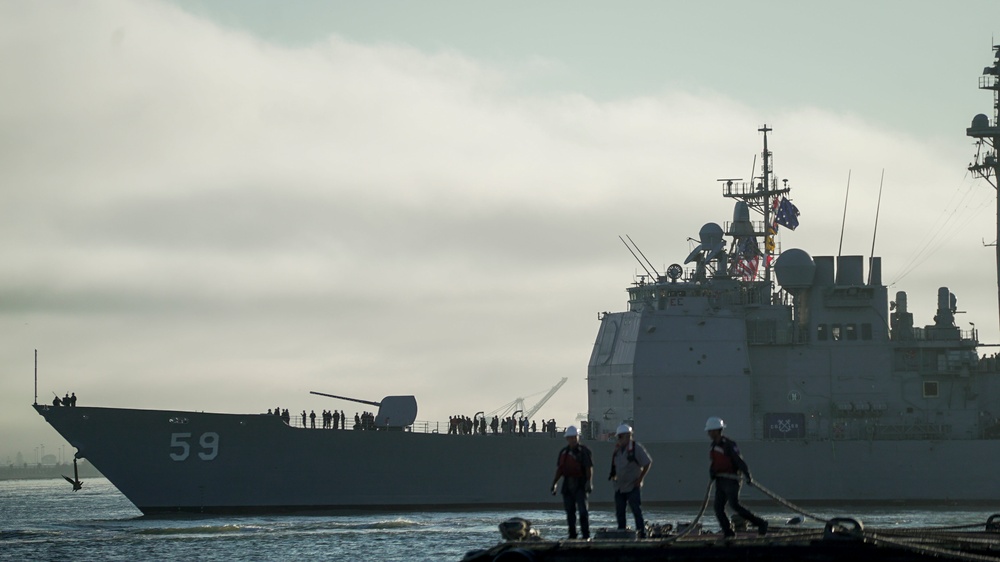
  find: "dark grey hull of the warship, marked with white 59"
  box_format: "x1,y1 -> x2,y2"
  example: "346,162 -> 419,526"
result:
35,406 -> 1000,514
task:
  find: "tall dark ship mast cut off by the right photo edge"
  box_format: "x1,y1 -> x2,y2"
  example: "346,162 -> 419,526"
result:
965,45 -> 1000,332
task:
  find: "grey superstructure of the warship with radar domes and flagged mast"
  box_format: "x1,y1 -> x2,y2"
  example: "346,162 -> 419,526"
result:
588,126 -> 1000,441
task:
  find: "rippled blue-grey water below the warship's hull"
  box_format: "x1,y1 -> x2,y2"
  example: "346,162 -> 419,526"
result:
0,478 -> 1000,562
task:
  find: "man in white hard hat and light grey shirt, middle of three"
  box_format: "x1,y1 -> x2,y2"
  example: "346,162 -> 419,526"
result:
608,423 -> 653,538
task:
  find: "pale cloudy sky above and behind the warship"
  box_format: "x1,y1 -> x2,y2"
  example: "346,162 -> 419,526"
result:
0,0 -> 1000,462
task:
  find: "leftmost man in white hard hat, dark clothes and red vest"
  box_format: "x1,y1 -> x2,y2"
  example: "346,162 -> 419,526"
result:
552,425 -> 594,540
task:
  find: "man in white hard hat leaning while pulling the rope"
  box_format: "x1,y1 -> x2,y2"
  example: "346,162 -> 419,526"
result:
705,416 -> 767,537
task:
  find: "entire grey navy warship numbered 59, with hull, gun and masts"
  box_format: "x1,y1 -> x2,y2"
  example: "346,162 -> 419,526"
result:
34,47 -> 1000,514
